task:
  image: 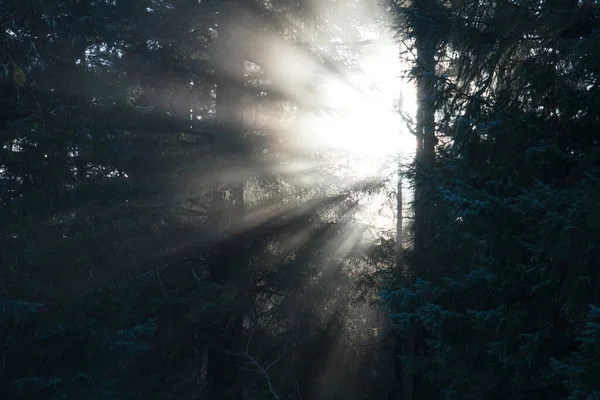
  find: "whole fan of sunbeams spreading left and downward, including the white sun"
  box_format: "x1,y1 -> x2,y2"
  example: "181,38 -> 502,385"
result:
169,0 -> 416,396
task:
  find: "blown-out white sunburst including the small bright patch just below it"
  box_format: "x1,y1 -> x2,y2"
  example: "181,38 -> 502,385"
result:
315,37 -> 416,232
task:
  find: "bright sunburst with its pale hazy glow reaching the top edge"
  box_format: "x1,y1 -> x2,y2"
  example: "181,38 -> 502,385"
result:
218,0 -> 416,234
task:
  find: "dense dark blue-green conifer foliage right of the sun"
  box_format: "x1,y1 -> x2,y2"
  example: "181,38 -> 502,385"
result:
383,1 -> 600,399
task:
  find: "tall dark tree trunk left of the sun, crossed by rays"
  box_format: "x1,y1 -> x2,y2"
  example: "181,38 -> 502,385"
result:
207,3 -> 246,400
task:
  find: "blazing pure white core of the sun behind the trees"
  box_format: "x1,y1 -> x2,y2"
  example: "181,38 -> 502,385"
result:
317,39 -> 415,158
